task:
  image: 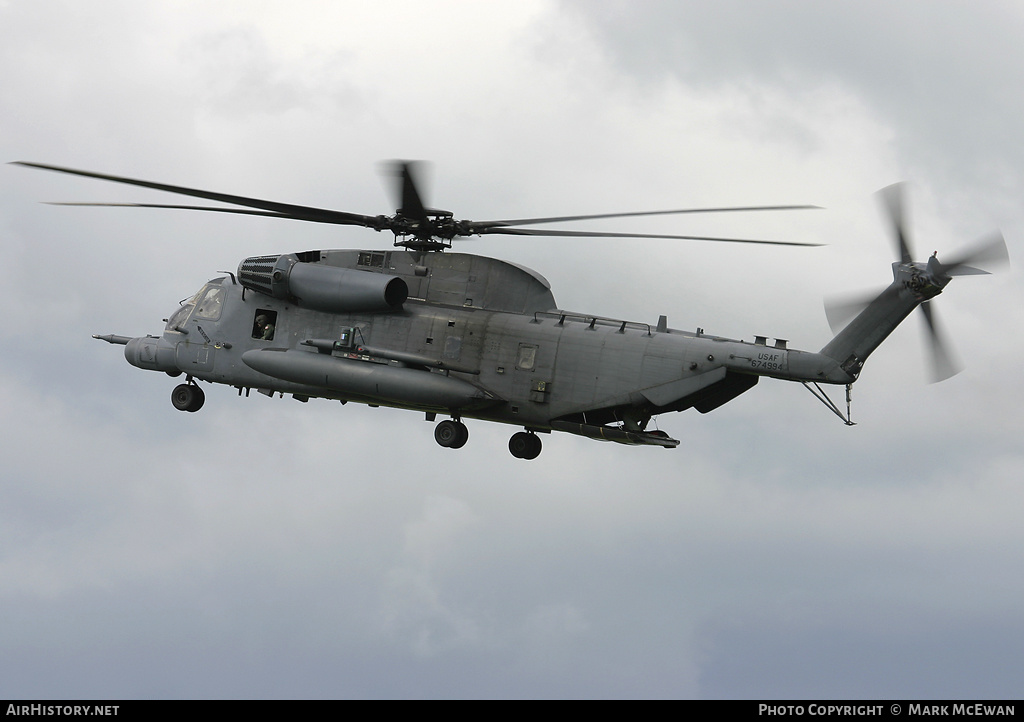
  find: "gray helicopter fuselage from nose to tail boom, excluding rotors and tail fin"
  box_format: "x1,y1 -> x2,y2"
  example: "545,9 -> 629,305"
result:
104,251 -> 854,456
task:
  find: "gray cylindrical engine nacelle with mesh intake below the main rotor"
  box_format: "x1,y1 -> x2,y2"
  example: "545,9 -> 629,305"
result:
239,253 -> 409,313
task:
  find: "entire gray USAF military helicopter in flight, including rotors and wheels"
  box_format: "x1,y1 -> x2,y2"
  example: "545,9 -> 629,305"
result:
17,162 -> 1009,459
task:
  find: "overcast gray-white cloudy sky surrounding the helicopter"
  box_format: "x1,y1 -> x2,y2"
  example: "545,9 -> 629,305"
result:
0,0 -> 1024,697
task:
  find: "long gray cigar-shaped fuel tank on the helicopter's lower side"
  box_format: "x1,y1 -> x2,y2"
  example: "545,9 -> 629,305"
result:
242,348 -> 501,411
